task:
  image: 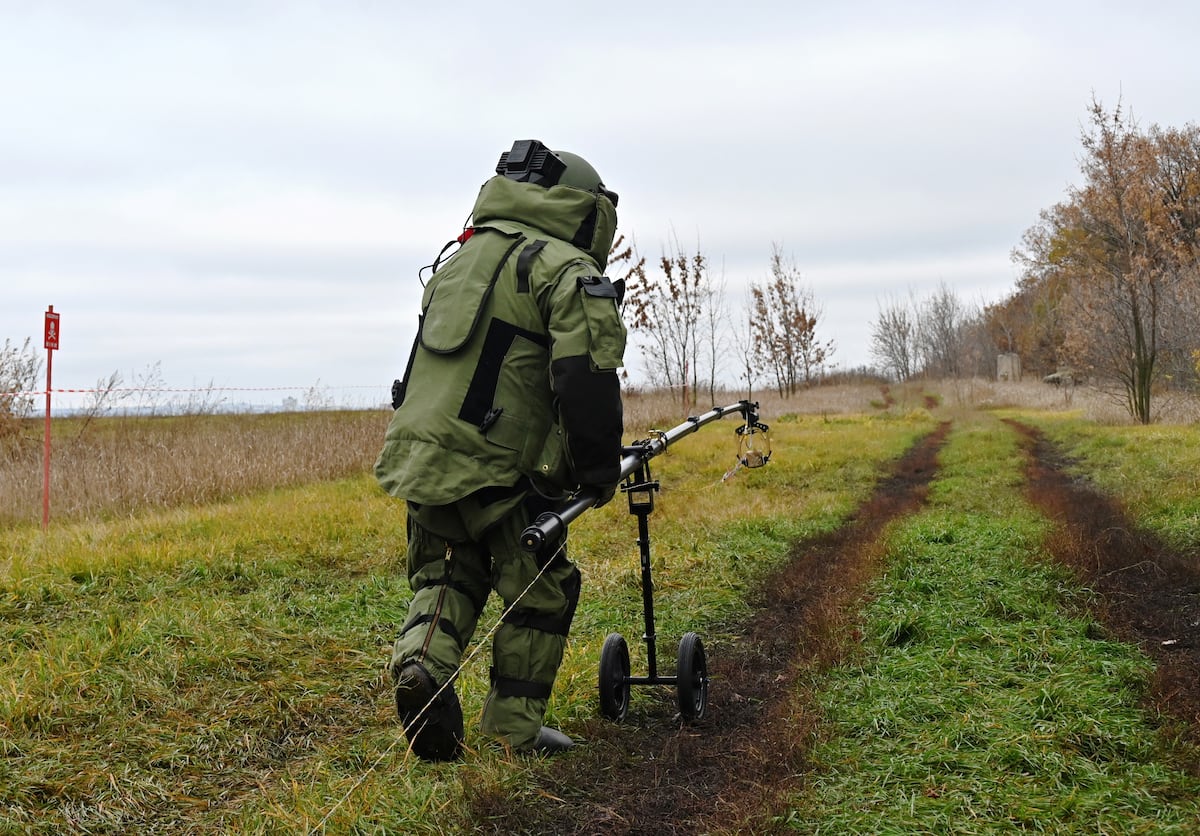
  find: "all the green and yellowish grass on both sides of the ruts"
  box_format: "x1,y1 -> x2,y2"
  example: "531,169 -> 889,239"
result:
0,392 -> 1200,834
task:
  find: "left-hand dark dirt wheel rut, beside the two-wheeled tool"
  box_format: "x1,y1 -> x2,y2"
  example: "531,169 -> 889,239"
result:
473,423 -> 949,836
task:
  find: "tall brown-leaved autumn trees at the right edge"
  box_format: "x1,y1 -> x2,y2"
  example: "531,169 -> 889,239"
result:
989,100 -> 1200,423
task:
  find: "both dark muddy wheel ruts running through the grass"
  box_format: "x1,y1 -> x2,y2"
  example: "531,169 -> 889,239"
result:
472,422 -> 1200,836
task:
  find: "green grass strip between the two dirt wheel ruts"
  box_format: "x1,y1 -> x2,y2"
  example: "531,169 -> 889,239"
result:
782,422 -> 1200,834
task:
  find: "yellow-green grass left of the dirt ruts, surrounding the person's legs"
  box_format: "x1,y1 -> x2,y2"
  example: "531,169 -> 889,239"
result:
0,410 -> 929,834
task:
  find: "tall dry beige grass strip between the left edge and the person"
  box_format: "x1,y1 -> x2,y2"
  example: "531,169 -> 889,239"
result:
0,410 -> 390,527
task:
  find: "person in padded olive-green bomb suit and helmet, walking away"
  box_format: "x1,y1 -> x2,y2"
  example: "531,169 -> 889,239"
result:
376,140 -> 625,760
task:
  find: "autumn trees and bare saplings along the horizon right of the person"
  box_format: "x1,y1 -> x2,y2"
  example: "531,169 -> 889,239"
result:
612,101 -> 1200,422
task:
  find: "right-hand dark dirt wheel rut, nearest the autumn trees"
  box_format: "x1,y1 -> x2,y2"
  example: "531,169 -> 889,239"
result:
1008,421 -> 1200,758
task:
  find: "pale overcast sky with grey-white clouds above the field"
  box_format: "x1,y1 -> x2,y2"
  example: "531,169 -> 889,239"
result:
0,0 -> 1200,405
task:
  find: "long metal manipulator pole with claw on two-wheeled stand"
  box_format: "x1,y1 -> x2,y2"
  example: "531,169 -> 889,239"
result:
521,401 -> 770,723
